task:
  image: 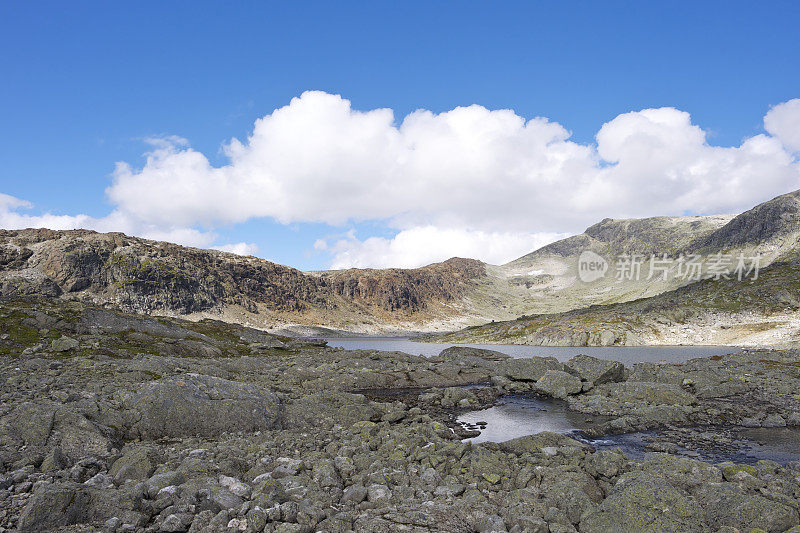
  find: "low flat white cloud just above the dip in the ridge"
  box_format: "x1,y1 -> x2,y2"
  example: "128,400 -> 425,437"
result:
328,226 -> 567,269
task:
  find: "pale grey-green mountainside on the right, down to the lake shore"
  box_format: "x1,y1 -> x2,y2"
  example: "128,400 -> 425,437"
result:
440,187 -> 800,346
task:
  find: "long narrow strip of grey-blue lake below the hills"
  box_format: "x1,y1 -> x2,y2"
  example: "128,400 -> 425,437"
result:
325,337 -> 741,365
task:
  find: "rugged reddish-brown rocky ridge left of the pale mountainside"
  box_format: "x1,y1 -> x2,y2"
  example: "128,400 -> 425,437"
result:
0,229 -> 486,325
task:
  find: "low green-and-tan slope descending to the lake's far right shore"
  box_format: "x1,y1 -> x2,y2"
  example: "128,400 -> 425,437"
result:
434,251 -> 800,346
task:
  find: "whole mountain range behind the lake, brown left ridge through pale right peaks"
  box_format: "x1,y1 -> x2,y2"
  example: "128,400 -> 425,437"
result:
0,191 -> 800,338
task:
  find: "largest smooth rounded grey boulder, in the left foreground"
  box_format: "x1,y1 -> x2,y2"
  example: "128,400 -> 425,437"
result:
122,374 -> 280,439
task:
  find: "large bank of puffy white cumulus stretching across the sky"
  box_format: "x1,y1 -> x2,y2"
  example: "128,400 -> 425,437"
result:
0,91 -> 800,267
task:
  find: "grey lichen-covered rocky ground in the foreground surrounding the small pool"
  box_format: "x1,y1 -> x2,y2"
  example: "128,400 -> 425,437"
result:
0,300 -> 800,532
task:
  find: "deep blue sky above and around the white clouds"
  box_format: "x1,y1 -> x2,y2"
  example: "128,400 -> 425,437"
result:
0,2 -> 800,269
